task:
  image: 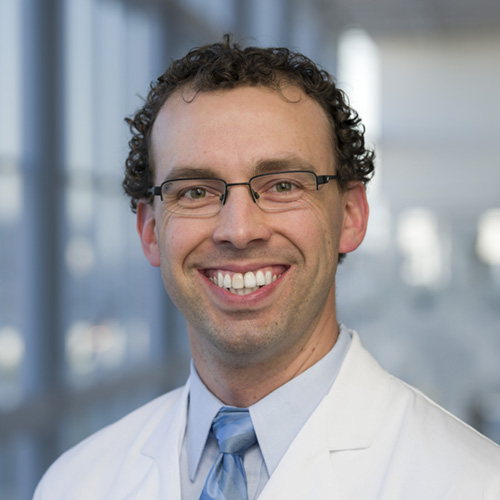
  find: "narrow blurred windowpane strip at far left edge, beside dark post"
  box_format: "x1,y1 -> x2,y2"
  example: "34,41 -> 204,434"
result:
0,0 -> 24,411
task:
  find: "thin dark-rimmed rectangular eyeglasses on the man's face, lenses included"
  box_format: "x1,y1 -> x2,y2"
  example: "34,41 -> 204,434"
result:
148,170 -> 339,217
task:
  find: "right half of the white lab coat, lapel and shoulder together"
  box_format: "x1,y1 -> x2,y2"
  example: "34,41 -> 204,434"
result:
261,332 -> 500,500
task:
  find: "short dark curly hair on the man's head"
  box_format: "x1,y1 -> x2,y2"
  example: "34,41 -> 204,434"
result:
123,35 -> 374,212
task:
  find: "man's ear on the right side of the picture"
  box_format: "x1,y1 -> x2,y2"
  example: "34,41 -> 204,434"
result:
339,182 -> 369,253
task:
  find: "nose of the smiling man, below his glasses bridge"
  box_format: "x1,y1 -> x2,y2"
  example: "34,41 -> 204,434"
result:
213,185 -> 271,249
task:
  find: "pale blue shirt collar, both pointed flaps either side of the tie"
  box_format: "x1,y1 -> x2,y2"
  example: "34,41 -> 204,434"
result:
187,326 -> 351,481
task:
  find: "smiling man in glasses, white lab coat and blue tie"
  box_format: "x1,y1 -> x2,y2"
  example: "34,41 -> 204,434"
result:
35,37 -> 500,500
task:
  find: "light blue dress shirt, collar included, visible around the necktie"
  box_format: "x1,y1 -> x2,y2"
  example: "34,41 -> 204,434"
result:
180,326 -> 351,500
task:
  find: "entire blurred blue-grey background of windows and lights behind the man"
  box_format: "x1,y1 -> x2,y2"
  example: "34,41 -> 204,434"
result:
0,0 -> 500,500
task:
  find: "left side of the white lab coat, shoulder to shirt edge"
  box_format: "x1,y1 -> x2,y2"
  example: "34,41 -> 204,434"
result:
34,383 -> 189,500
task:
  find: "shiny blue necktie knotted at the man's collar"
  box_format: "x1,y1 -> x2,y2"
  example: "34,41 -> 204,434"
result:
200,407 -> 257,500
